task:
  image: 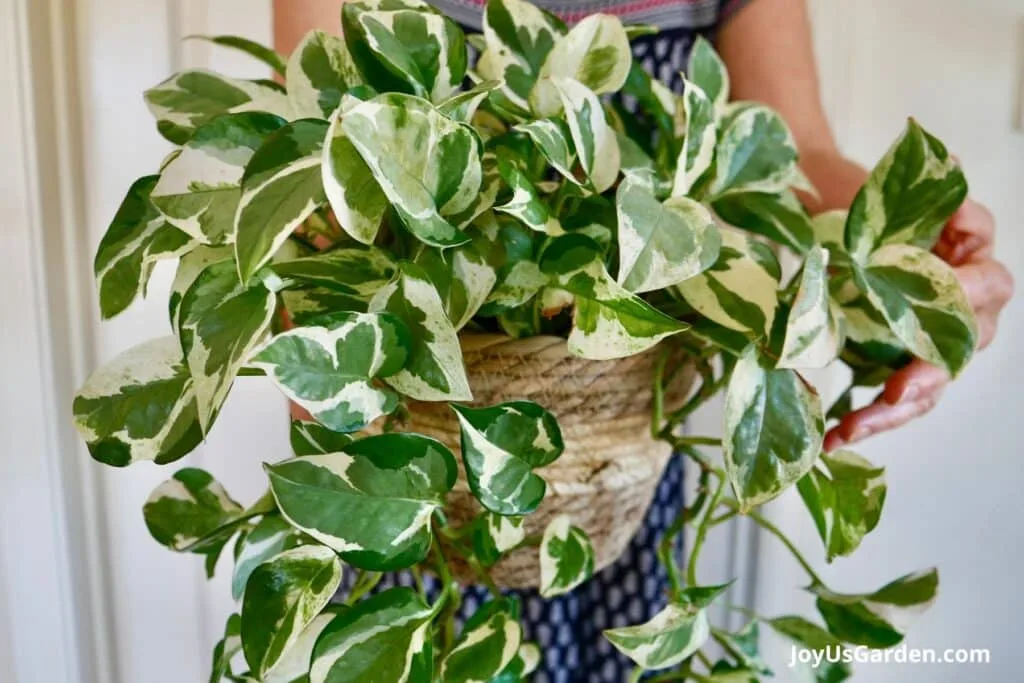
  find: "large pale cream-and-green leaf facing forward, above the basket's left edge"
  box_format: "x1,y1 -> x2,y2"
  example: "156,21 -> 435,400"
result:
341,93 -> 483,247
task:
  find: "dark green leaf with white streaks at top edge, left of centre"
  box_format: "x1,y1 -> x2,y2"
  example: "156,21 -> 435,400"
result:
342,2 -> 468,102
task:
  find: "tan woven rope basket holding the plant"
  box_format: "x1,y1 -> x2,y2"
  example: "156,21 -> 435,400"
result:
380,335 -> 693,588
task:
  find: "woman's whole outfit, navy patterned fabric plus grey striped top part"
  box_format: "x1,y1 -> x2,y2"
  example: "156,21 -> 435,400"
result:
349,0 -> 749,683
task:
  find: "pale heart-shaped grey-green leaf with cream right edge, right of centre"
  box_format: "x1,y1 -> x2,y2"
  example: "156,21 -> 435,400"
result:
615,175 -> 721,293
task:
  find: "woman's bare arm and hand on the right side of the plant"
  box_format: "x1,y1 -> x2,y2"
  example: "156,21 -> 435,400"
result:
718,0 -> 1014,451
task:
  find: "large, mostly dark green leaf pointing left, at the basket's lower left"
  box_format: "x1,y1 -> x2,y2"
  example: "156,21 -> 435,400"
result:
264,433 -> 458,571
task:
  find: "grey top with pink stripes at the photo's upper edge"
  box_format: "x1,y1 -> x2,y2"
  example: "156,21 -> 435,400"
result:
428,0 -> 749,33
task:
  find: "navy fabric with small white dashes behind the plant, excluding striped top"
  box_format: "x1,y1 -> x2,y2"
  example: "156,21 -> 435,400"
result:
347,5 -> 746,683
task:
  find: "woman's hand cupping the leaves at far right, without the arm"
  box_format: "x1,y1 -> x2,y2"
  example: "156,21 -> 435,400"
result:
825,200 -> 1014,451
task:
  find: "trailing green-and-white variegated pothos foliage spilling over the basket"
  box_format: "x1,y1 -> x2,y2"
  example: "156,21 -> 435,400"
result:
74,0 -> 976,683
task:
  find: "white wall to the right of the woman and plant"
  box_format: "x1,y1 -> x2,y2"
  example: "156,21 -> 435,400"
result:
758,0 -> 1024,683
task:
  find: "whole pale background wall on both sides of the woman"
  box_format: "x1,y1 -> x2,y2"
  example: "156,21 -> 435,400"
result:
0,0 -> 1024,683
